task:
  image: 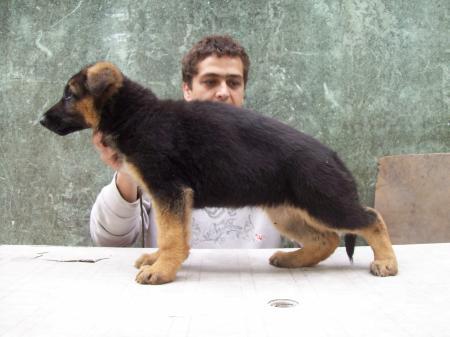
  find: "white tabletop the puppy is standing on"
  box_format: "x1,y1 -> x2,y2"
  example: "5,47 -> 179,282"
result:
0,243 -> 450,337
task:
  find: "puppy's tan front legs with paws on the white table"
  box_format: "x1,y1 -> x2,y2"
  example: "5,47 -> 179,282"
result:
136,189 -> 193,284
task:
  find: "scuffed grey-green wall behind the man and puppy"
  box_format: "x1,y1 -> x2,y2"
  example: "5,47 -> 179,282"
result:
0,0 -> 450,245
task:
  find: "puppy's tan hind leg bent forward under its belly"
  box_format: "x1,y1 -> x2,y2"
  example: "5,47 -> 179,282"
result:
265,207 -> 339,268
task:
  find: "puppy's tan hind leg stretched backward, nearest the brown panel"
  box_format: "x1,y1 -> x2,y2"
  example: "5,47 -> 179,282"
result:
353,207 -> 398,276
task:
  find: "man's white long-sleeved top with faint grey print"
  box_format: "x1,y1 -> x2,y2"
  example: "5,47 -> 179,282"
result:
90,176 -> 281,248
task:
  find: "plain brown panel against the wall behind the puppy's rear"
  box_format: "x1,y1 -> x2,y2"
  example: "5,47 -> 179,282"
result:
375,153 -> 450,244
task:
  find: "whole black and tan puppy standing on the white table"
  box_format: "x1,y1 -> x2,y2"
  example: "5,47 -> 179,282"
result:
41,62 -> 397,284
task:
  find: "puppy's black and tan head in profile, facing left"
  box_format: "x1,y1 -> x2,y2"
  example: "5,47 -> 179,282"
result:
40,62 -> 123,136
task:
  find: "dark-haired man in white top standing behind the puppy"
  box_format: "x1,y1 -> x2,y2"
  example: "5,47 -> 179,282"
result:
90,35 -> 281,248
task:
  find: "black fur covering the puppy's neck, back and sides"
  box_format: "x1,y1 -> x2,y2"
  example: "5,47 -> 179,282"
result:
98,78 -> 369,229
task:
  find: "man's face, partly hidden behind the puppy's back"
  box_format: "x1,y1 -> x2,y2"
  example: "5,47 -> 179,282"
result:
183,55 -> 245,106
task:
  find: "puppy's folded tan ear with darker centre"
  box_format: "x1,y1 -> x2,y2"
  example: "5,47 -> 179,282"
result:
86,62 -> 123,98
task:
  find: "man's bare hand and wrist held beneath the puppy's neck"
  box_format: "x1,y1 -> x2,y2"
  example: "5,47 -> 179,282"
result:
92,131 -> 137,202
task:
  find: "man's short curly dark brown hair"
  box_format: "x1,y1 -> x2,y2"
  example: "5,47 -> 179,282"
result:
181,35 -> 250,86
